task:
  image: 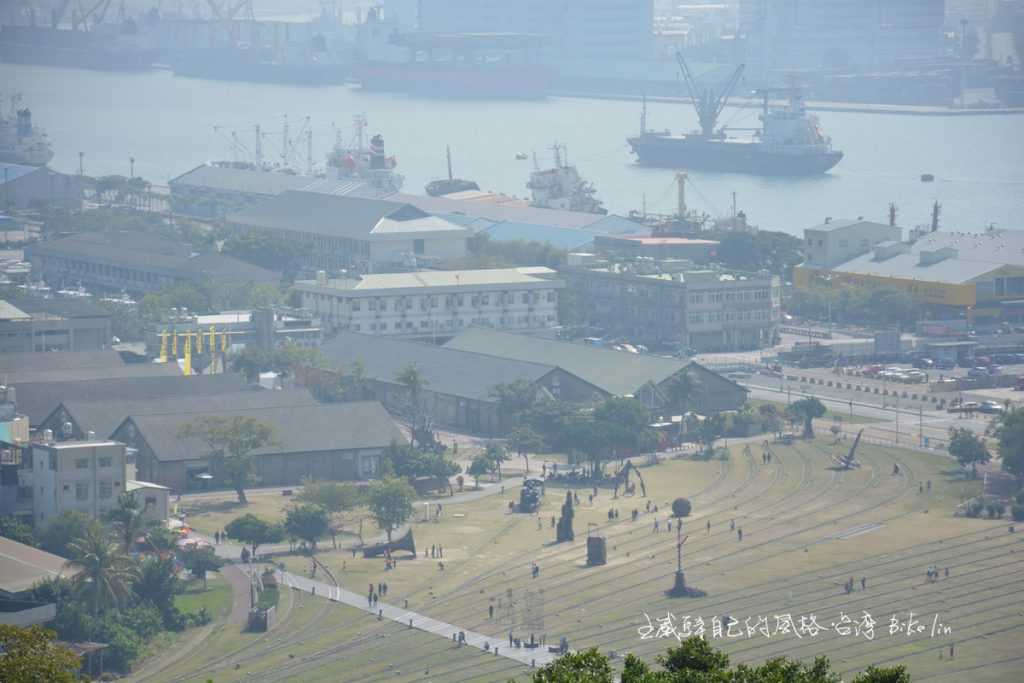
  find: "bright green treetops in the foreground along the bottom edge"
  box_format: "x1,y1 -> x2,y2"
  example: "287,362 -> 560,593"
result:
531,638 -> 910,683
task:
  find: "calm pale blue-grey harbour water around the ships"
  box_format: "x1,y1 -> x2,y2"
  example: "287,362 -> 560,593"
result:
6,65 -> 1024,234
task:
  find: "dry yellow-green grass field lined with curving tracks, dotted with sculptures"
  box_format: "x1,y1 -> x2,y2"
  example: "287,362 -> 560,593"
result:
138,438 -> 1024,683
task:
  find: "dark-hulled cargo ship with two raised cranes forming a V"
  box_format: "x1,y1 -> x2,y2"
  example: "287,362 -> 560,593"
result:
628,54 -> 843,175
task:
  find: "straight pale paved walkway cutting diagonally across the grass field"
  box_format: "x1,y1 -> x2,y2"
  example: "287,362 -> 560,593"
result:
278,571 -> 556,667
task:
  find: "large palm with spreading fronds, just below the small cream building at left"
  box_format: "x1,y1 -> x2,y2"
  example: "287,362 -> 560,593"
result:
68,527 -> 138,616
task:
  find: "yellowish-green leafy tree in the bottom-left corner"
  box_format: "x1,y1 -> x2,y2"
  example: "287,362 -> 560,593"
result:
0,625 -> 80,683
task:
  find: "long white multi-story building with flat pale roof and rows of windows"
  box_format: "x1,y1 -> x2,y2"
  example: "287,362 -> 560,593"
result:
295,267 -> 564,337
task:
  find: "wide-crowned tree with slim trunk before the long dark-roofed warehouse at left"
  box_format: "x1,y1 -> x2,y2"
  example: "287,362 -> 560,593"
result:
178,416 -> 275,505
